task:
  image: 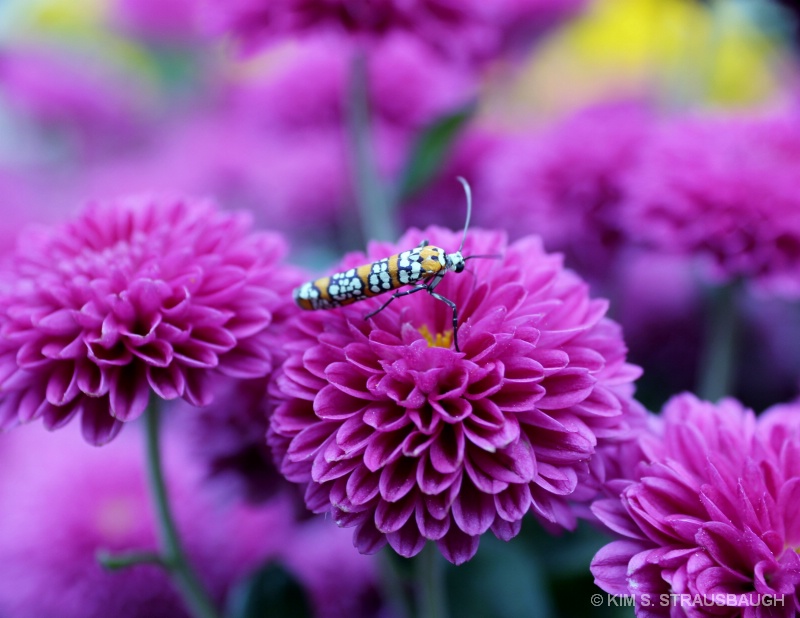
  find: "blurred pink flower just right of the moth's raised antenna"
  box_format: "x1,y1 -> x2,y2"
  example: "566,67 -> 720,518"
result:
476,103 -> 652,281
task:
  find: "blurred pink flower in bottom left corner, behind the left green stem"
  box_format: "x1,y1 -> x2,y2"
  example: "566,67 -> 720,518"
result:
0,426 -> 244,618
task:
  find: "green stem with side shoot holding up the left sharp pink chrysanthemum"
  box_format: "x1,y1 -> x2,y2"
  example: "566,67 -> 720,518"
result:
145,397 -> 219,618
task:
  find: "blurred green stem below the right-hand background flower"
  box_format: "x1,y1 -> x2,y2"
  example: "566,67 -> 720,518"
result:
698,283 -> 739,401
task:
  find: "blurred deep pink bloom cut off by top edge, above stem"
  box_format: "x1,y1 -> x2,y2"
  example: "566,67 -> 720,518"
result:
205,0 -> 584,61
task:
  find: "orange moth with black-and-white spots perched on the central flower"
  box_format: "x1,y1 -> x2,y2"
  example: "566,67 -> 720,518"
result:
294,177 -> 499,351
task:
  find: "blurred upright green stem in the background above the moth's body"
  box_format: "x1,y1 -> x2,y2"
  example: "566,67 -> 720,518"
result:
347,51 -> 397,241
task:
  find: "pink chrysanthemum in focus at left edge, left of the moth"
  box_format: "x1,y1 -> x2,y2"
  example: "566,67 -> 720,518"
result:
0,198 -> 296,444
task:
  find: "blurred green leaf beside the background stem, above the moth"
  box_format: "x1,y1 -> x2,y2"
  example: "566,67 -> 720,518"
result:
397,101 -> 478,201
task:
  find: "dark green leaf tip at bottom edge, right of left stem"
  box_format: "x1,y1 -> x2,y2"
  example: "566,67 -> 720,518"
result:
225,562 -> 313,618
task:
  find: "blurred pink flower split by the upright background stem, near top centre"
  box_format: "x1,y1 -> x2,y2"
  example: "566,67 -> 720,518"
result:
228,33 -> 478,132
